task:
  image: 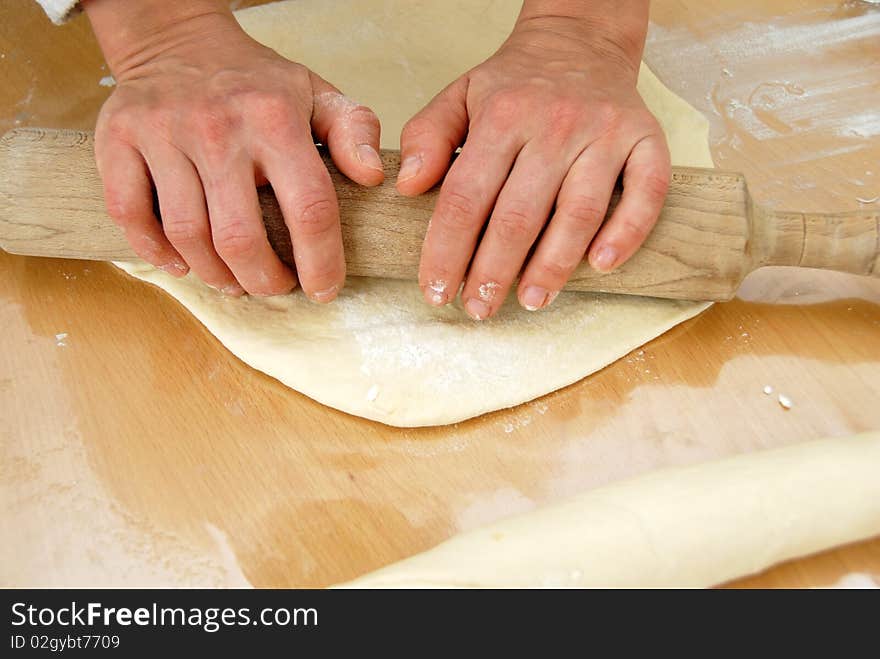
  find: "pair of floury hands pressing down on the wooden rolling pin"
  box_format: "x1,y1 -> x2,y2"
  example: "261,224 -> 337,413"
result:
85,0 -> 670,319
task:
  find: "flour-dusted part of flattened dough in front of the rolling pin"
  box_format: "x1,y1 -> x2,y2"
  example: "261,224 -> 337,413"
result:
119,264 -> 707,426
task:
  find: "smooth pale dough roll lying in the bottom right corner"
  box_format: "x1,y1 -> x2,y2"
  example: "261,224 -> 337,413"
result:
343,432 -> 880,588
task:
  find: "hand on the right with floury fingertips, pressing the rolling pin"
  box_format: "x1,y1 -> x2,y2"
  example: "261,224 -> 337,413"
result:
397,10 -> 670,320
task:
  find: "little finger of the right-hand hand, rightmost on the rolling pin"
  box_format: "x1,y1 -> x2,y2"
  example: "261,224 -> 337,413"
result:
589,133 -> 672,272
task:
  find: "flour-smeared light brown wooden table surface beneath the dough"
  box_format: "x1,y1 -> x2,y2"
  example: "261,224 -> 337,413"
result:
0,0 -> 880,586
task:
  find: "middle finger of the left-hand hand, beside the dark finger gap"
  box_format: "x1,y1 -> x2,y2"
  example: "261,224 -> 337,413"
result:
202,157 -> 296,295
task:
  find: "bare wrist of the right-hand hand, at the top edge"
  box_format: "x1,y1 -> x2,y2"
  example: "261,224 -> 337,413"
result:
514,0 -> 650,72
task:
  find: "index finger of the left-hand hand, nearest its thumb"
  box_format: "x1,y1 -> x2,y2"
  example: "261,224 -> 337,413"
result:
261,139 -> 345,302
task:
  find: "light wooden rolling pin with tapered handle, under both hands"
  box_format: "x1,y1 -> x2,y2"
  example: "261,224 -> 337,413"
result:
0,128 -> 880,300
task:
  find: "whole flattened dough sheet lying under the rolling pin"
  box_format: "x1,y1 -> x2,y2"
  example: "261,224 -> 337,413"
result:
111,0 -> 712,426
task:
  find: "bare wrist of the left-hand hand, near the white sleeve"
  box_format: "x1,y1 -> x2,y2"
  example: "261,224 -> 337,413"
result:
82,0 -> 241,79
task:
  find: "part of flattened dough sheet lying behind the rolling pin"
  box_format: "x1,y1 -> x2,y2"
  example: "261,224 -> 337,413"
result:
235,0 -> 713,160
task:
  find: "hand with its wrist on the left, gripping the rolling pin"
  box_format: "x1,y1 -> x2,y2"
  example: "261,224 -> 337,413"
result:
84,0 -> 383,302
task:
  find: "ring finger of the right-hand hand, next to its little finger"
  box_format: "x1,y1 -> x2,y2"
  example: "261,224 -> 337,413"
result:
517,142 -> 626,311
